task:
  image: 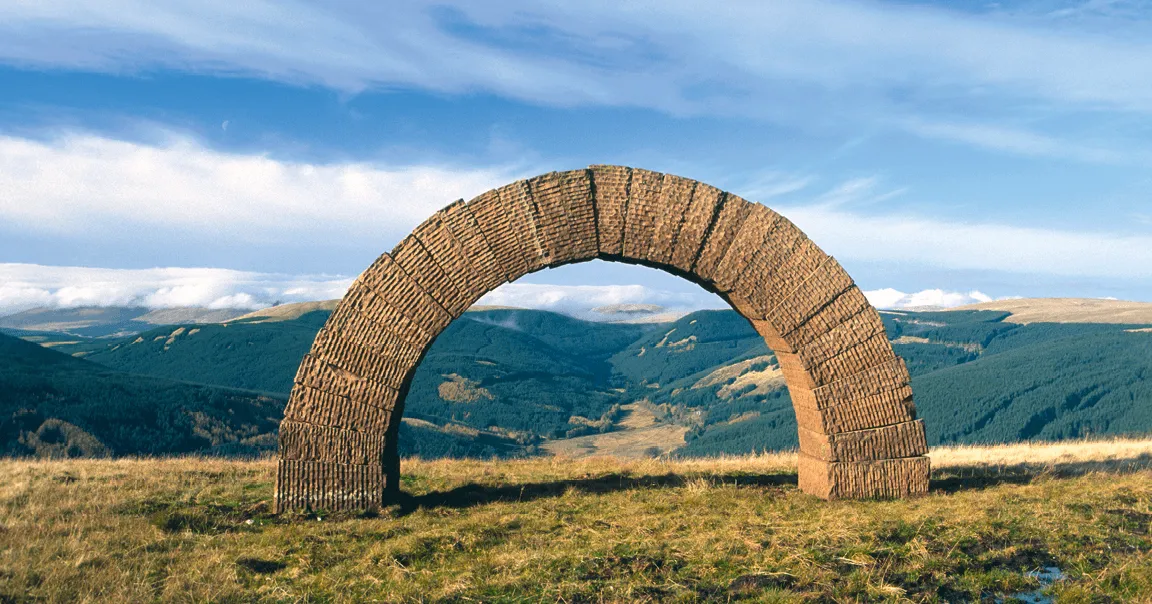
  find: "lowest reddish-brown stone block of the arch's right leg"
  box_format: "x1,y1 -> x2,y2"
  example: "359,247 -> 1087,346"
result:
799,453 -> 930,499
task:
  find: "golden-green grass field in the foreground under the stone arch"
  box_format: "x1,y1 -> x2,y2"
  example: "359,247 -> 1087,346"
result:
0,440 -> 1152,602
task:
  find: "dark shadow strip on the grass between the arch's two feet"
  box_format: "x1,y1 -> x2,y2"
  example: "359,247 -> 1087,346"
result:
399,473 -> 796,515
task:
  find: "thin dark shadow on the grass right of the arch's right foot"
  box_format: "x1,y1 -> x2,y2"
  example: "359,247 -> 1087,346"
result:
929,453 -> 1152,493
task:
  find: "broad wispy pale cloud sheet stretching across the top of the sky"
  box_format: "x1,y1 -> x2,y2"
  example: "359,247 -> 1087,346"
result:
0,0 -> 1152,125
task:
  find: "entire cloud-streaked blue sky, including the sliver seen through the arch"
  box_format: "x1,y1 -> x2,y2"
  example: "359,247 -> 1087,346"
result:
0,0 -> 1152,311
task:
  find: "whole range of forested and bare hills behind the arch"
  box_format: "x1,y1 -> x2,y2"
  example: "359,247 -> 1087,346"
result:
0,301 -> 1152,456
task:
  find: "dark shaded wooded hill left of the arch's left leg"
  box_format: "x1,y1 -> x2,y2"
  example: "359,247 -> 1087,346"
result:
0,334 -> 285,456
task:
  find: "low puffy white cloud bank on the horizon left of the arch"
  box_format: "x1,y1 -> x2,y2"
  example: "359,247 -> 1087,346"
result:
0,264 -> 353,315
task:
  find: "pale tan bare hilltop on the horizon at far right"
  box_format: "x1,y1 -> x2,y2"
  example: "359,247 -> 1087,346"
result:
955,297 -> 1152,324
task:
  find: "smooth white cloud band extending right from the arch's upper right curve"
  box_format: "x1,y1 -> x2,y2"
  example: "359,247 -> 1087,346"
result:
776,205 -> 1152,280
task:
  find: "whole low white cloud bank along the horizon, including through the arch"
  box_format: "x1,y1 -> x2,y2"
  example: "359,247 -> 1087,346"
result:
0,264 -> 992,316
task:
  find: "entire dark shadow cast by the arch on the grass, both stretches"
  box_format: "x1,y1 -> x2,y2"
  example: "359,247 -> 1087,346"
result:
397,454 -> 1152,515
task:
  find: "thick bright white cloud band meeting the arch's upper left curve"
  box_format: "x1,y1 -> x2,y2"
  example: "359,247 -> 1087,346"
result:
0,134 -> 514,244
